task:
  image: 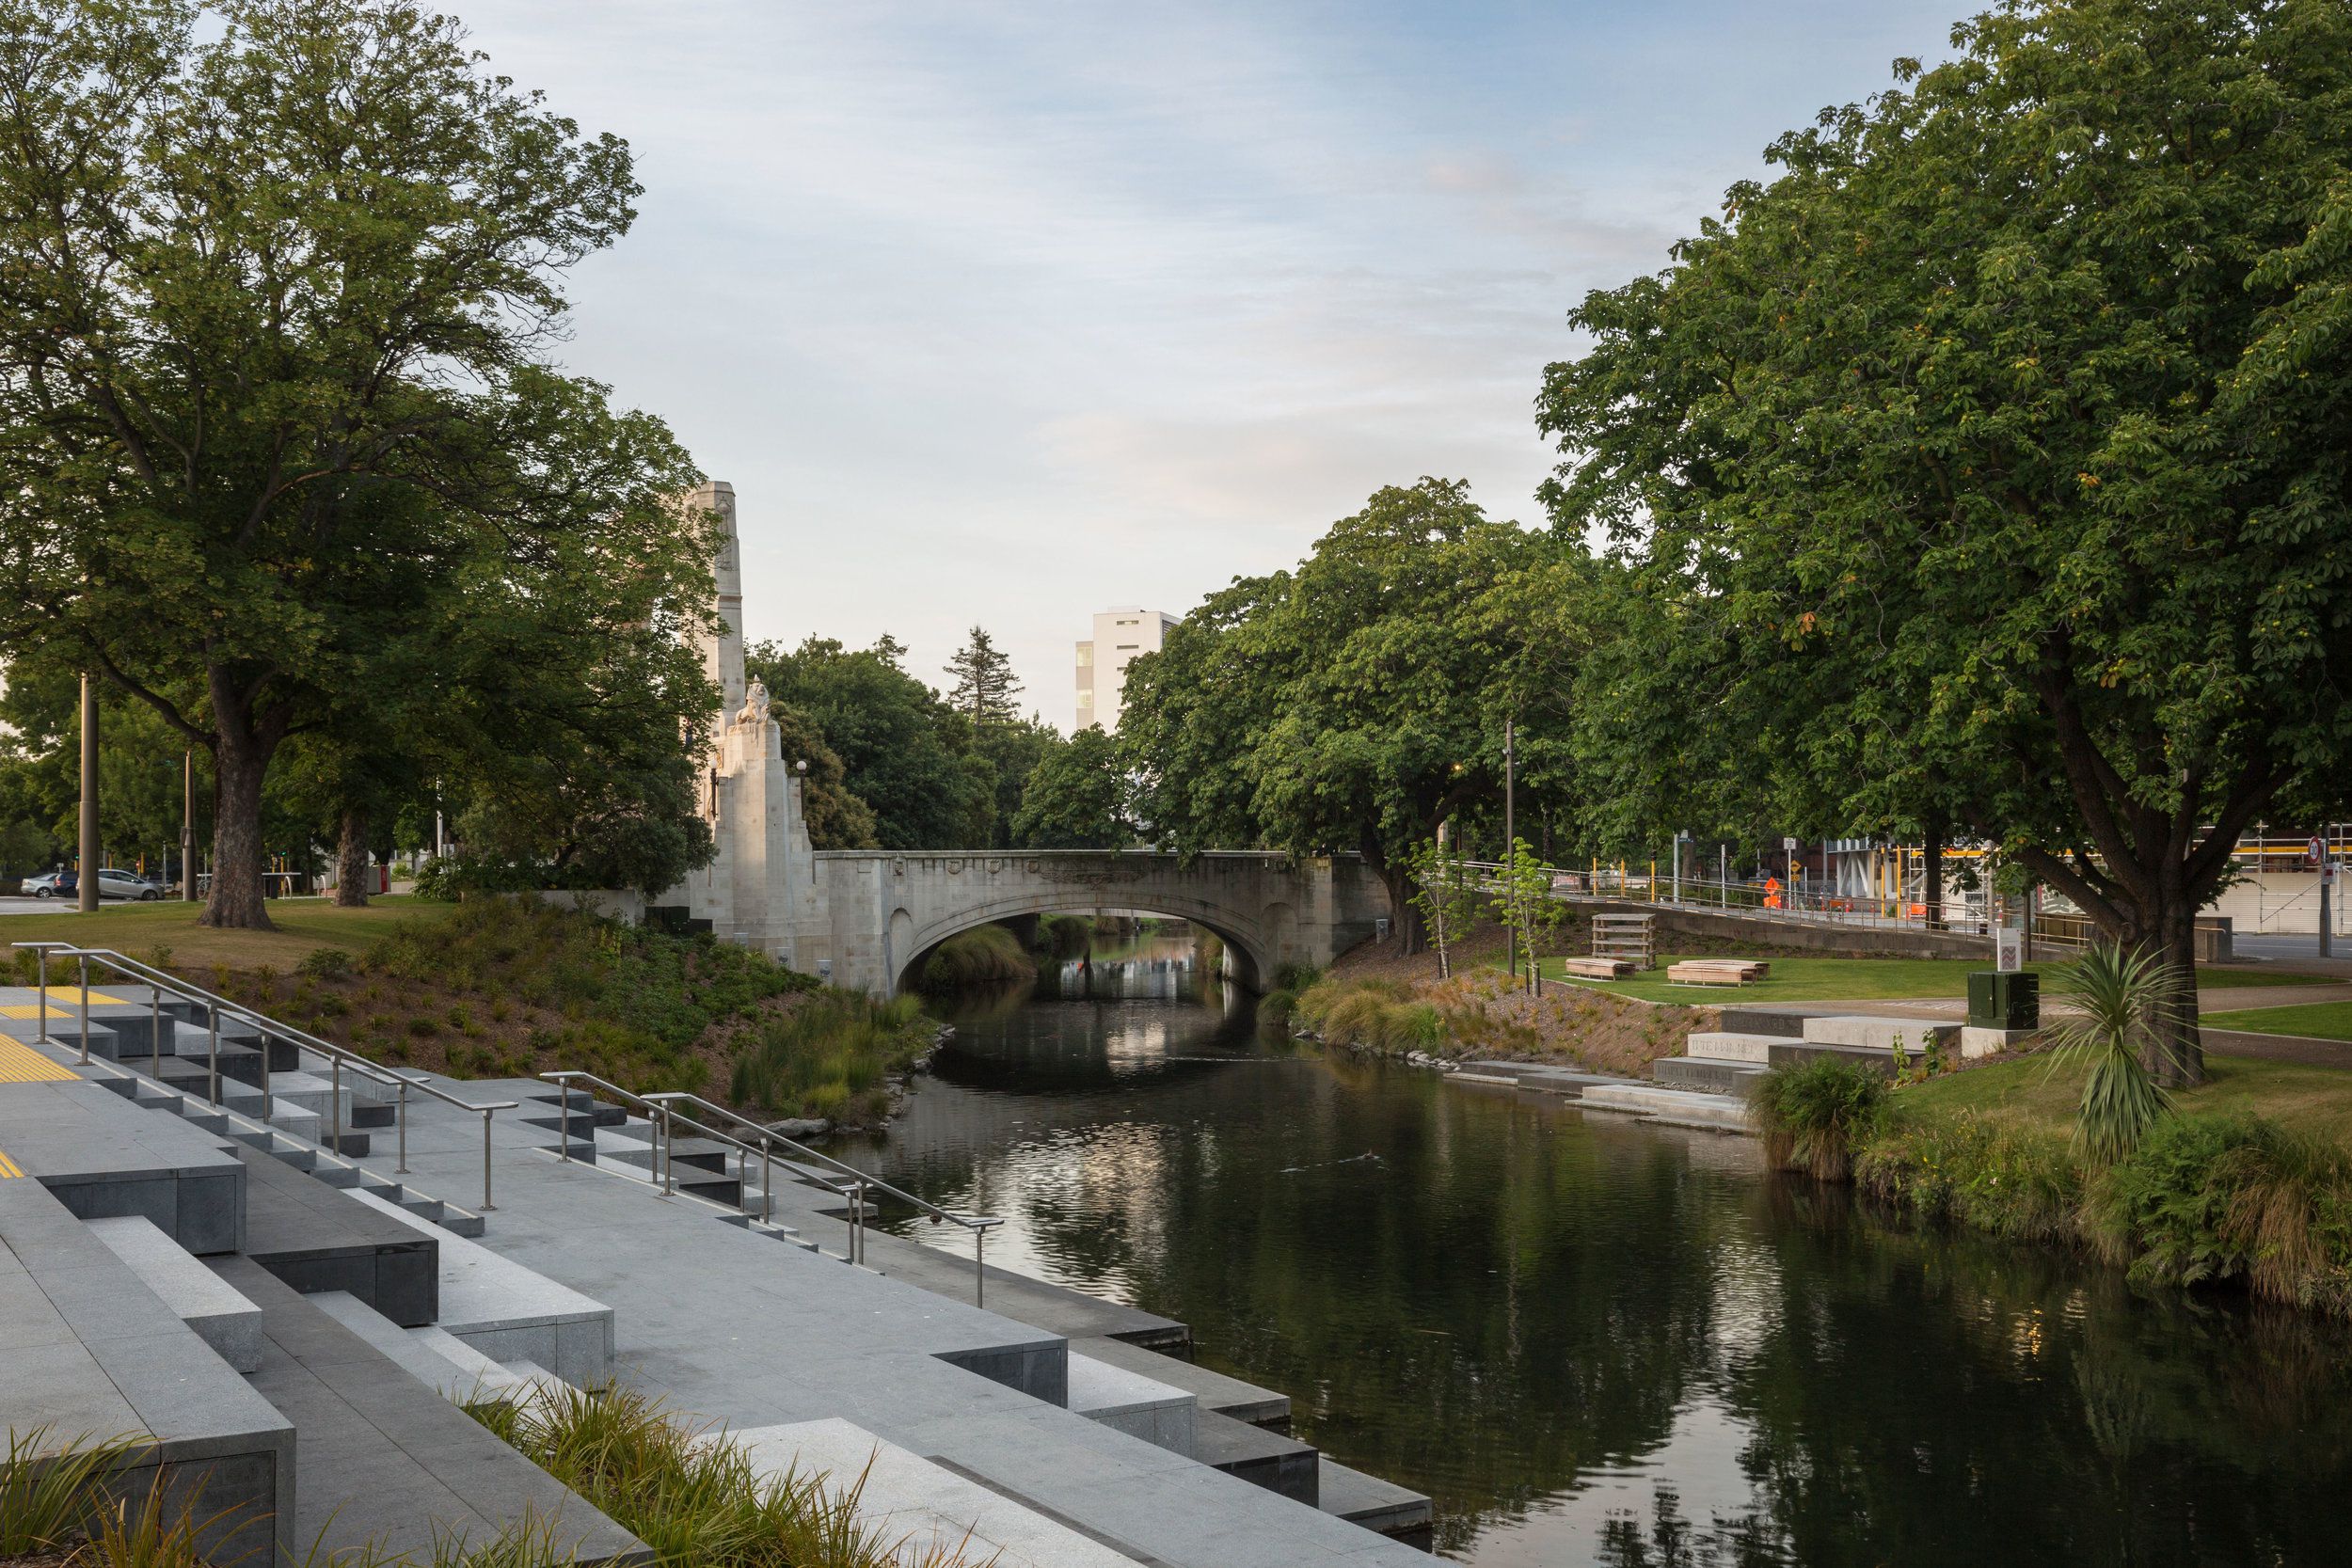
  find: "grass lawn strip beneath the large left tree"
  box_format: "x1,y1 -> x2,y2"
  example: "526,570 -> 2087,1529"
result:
0,894 -> 456,974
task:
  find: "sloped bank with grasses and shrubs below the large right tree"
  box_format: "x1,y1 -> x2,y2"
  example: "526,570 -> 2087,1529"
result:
1753,1055 -> 2352,1319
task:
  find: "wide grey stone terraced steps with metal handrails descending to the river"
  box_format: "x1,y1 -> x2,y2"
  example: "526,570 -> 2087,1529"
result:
0,968 -> 1430,1568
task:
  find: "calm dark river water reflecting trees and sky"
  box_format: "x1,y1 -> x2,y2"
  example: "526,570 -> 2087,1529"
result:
861,957 -> 2352,1568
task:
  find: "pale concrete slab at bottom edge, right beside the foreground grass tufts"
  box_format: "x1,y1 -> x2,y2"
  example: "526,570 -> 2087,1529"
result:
727,1418 -> 1157,1568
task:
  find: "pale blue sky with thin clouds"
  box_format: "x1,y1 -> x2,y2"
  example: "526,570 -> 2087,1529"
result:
450,0 -> 1966,729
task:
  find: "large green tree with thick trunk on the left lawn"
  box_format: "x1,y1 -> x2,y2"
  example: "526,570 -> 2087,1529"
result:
0,0 -> 708,927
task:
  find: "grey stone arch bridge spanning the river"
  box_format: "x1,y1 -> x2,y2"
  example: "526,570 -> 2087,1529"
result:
814,848 -> 1388,997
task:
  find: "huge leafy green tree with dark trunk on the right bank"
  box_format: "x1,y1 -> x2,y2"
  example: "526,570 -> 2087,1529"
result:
1541,0 -> 2352,1084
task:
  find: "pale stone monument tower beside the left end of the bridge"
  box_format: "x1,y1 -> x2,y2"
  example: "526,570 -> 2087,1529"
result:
657,480 -> 831,974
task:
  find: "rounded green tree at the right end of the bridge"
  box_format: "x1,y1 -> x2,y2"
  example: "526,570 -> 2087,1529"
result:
1120,480 -> 1590,952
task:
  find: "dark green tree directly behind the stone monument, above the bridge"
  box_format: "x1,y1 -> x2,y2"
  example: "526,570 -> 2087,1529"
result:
743,637 -> 995,848
